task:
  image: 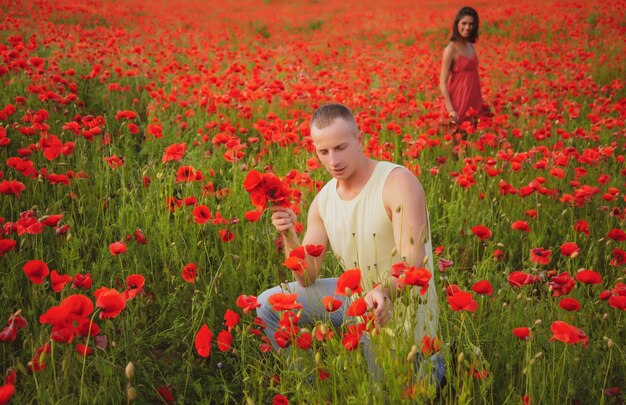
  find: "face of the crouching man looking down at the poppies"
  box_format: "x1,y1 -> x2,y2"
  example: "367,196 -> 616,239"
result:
311,118 -> 362,180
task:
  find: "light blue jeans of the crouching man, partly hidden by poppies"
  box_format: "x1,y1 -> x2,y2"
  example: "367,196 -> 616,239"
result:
256,278 -> 445,387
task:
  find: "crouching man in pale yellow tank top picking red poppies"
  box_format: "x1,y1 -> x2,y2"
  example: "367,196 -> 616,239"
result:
257,104 -> 443,381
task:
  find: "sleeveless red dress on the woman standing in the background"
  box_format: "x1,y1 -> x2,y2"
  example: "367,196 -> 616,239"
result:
448,53 -> 483,125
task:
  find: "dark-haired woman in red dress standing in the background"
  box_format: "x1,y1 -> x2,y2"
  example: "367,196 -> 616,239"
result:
439,7 -> 483,127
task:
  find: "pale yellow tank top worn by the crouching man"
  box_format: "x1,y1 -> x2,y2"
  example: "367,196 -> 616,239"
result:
318,161 -> 438,343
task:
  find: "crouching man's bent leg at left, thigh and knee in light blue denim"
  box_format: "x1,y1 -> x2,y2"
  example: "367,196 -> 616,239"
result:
256,278 -> 346,349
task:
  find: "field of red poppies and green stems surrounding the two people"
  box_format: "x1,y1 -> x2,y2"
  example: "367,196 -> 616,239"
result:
0,0 -> 626,404
